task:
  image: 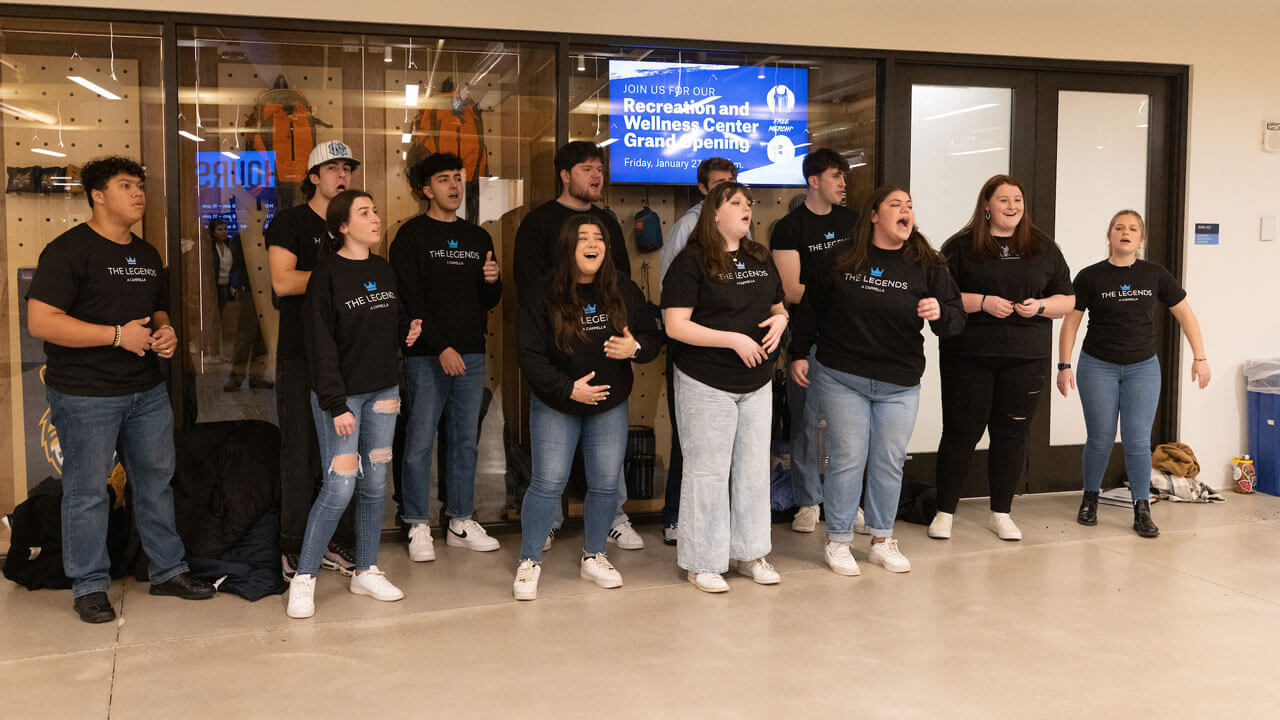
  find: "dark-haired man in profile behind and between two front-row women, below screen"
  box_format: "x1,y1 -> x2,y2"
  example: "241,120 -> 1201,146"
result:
769,147 -> 860,533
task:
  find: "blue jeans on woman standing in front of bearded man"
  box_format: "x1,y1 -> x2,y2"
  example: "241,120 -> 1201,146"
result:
520,396 -> 627,562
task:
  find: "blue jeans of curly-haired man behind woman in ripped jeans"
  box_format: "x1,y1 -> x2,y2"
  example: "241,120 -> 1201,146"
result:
401,352 -> 484,524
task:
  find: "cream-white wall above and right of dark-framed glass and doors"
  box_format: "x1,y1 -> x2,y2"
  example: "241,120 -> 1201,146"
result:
30,0 -> 1280,484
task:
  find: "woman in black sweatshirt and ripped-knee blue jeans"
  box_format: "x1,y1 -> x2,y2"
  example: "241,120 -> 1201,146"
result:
287,190 -> 422,618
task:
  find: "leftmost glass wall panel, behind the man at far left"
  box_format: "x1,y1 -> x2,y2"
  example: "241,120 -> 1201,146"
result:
0,18 -> 170,514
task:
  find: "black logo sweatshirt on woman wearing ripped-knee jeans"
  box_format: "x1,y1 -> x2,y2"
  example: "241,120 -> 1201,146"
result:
303,254 -> 408,418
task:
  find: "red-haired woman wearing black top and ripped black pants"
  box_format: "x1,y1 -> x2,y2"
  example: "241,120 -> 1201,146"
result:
929,176 -> 1073,541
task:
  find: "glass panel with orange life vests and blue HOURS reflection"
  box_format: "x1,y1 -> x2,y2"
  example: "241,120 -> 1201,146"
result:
178,27 -> 556,523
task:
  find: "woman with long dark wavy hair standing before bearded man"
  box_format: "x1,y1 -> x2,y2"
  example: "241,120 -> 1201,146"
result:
512,214 -> 662,600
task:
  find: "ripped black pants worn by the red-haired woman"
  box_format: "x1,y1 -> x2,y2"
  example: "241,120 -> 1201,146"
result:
937,352 -> 1044,512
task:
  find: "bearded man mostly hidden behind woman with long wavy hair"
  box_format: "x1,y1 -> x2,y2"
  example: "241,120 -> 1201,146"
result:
513,140 -> 644,550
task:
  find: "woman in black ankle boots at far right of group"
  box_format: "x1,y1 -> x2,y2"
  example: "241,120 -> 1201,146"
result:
1057,210 -> 1210,538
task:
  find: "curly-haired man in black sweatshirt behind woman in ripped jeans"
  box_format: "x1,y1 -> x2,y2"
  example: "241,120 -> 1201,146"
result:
390,152 -> 502,562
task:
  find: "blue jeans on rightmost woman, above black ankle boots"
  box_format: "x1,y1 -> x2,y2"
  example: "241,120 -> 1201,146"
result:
1075,352 -> 1160,500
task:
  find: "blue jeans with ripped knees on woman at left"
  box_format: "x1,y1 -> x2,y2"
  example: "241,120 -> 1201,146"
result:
298,387 -> 399,575
